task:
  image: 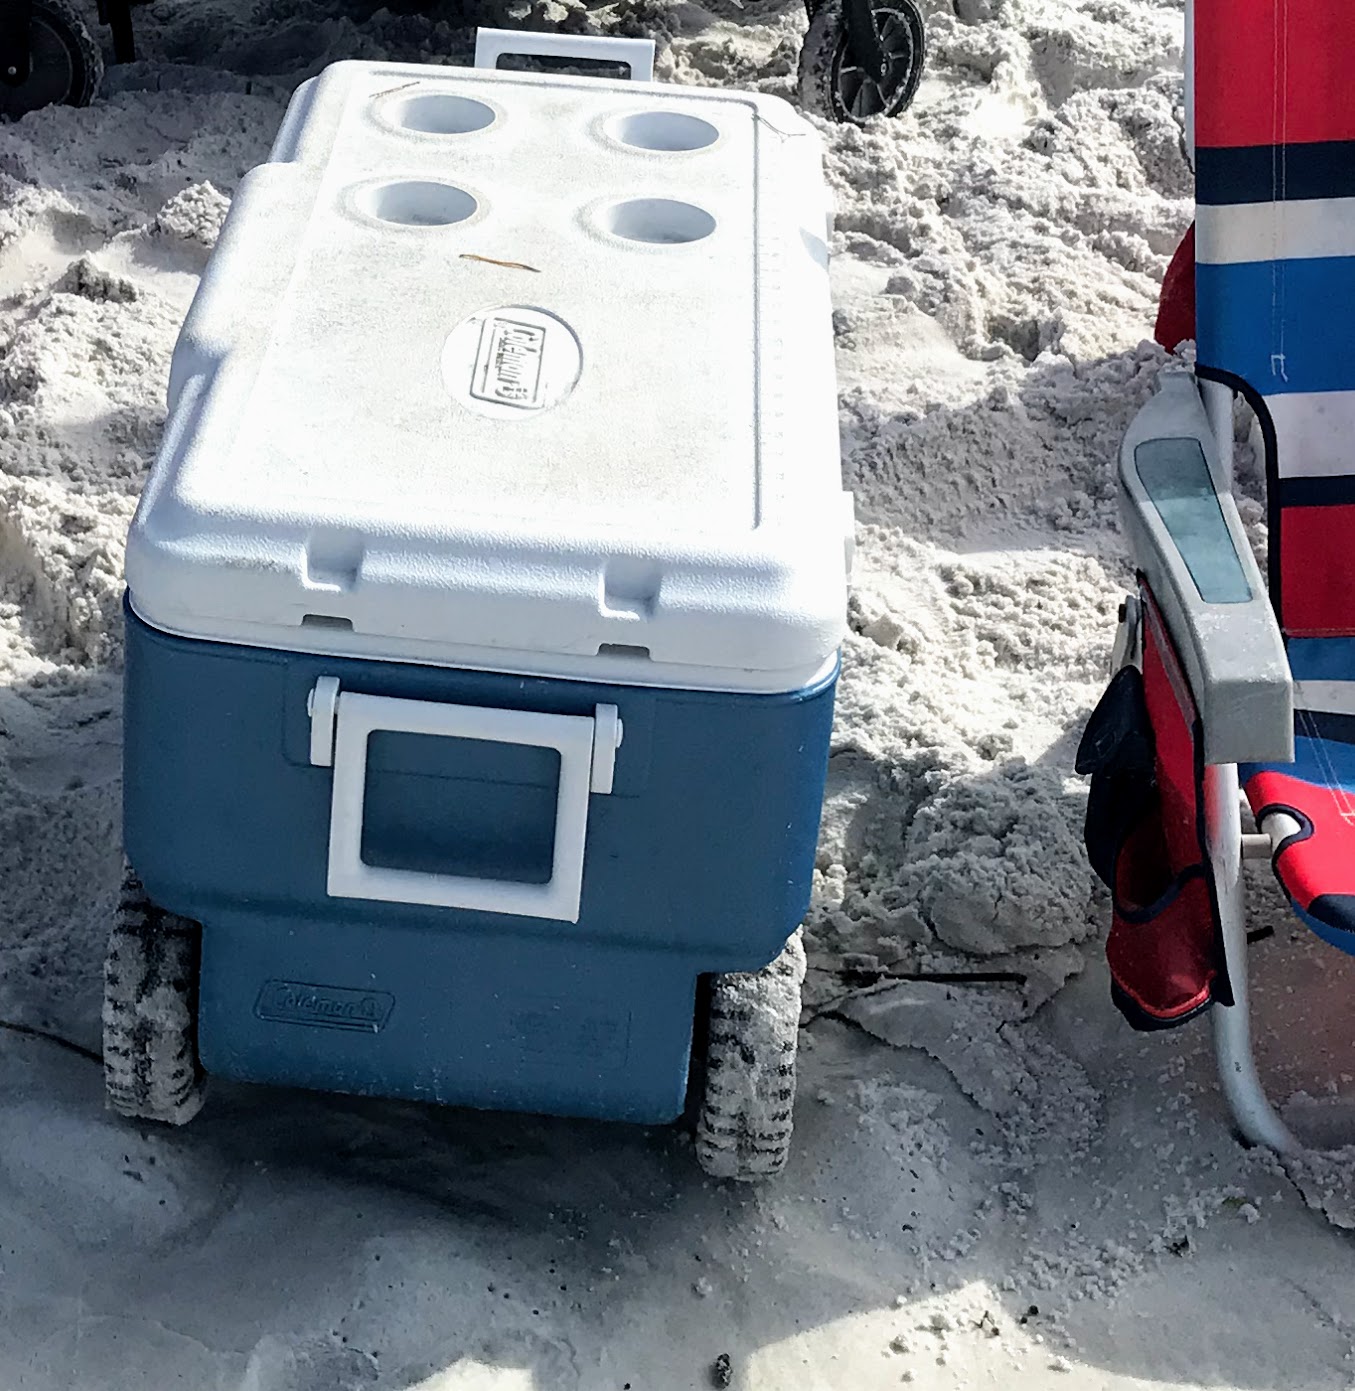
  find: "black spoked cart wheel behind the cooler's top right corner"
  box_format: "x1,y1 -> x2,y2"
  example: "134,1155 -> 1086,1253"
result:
800,0 -> 927,122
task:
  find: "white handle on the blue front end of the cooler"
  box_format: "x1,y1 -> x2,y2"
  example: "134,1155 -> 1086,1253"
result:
307,676 -> 622,922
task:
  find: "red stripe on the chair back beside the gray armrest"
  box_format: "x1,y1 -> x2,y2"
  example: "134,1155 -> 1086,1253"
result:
1280,504 -> 1355,637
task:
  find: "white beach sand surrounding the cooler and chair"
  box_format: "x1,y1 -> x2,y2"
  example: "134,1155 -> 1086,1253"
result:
0,0 -> 1355,1391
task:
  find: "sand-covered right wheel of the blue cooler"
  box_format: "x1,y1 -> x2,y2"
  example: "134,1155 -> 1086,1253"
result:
696,932 -> 804,1182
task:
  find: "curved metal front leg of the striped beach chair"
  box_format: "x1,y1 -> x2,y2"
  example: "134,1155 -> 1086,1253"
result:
1205,764 -> 1304,1155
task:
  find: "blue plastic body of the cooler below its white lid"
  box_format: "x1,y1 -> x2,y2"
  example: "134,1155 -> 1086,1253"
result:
124,608 -> 836,1124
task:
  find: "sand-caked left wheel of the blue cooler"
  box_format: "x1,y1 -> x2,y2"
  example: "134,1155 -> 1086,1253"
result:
103,867 -> 203,1125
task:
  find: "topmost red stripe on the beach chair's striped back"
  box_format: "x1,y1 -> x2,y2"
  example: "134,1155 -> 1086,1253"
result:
1195,0 -> 1355,149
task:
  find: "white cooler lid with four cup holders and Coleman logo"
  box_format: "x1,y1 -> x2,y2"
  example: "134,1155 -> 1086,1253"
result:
127,54 -> 851,690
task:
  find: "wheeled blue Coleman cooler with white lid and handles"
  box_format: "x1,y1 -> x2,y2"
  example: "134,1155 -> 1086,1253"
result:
104,32 -> 851,1177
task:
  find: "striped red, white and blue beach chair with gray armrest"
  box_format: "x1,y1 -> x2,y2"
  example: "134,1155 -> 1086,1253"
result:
1078,0 -> 1355,1153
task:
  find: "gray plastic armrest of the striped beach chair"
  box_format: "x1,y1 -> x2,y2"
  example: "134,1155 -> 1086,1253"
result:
1120,371 -> 1294,764
